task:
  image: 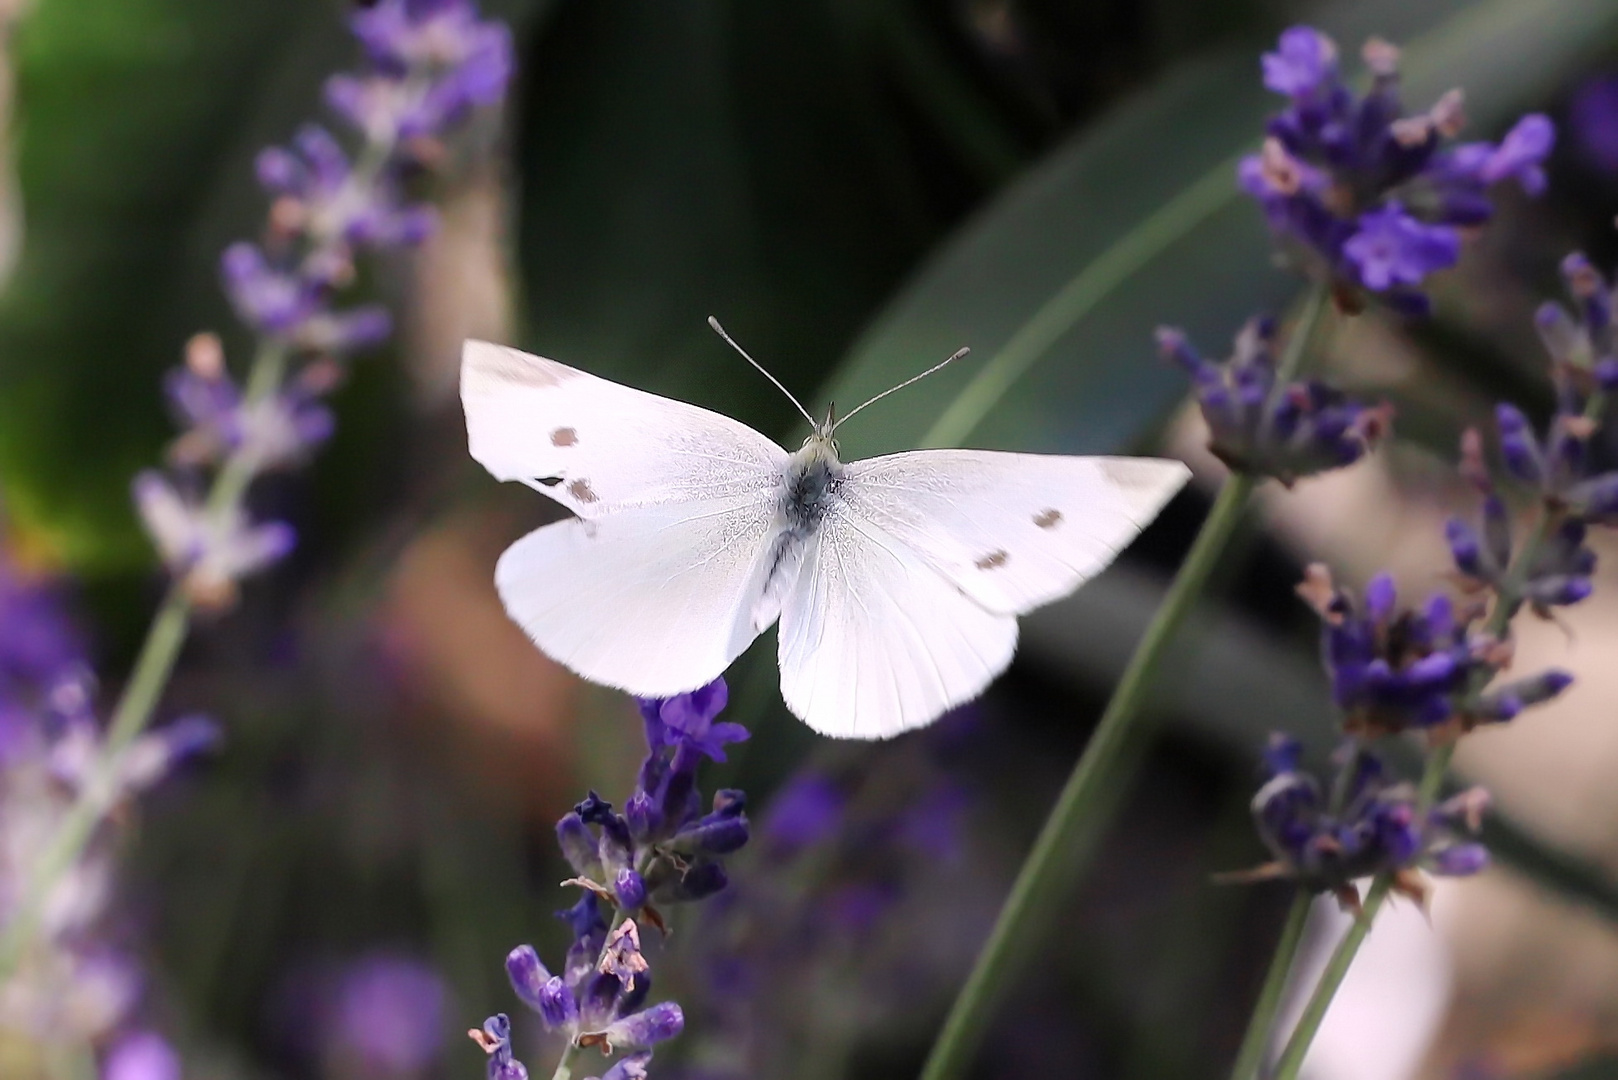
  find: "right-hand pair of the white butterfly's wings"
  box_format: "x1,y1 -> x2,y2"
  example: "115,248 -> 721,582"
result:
780,450 -> 1189,738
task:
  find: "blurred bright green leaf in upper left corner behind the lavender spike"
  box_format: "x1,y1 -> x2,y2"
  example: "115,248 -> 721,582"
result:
0,0 -> 540,573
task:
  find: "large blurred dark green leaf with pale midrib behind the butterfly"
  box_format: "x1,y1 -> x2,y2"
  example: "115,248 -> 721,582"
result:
827,0 -> 1618,453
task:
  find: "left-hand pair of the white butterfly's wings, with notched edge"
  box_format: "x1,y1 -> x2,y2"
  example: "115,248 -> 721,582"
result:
461,342 -> 786,696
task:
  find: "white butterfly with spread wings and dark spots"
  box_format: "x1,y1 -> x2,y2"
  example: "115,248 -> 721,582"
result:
461,331 -> 1188,738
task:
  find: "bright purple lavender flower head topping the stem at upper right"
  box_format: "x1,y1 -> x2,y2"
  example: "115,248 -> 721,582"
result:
1238,26 -> 1555,314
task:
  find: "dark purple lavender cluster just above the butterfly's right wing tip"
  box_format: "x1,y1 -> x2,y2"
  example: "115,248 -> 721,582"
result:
1157,319 -> 1391,484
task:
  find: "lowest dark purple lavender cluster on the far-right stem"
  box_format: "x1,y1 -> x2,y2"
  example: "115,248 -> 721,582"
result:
1225,735 -> 1489,910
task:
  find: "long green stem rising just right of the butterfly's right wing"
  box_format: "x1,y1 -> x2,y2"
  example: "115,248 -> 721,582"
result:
921,287 -> 1327,1080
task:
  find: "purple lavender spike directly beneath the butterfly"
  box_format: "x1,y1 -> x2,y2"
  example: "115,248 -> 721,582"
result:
471,678 -> 749,1080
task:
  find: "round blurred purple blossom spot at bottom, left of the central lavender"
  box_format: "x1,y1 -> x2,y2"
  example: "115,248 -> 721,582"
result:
328,954 -> 447,1077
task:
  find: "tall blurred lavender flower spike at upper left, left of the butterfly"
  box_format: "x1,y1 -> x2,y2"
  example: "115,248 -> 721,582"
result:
134,0 -> 511,607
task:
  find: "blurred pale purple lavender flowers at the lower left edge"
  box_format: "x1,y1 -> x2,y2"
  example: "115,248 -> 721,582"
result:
0,560 -> 218,1080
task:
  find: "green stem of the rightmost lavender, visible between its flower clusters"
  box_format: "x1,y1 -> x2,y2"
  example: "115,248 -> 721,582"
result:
1275,386 -> 1607,1080
